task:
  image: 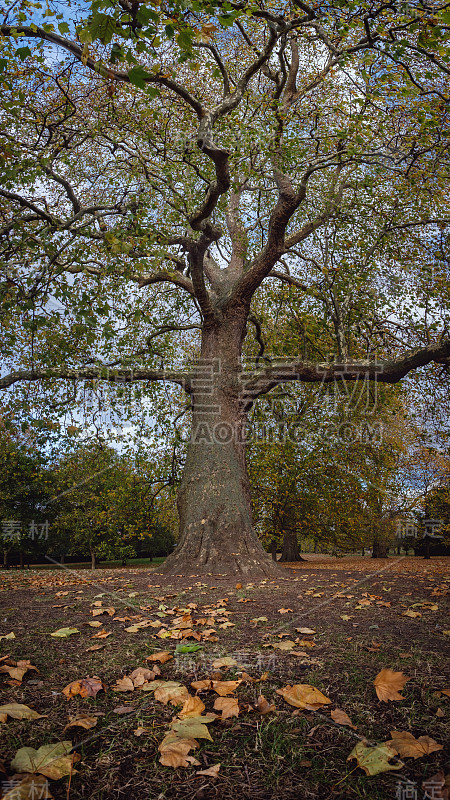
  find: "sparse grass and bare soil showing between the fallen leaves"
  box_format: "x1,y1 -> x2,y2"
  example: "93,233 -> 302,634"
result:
0,562 -> 450,800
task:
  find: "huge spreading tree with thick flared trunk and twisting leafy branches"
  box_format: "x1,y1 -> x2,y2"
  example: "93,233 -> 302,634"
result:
0,0 -> 450,574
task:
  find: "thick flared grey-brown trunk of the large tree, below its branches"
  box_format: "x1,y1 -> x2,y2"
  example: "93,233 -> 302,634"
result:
161,315 -> 280,577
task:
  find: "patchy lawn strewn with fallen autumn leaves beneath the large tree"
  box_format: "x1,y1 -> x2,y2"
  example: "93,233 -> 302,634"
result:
0,558 -> 450,800
